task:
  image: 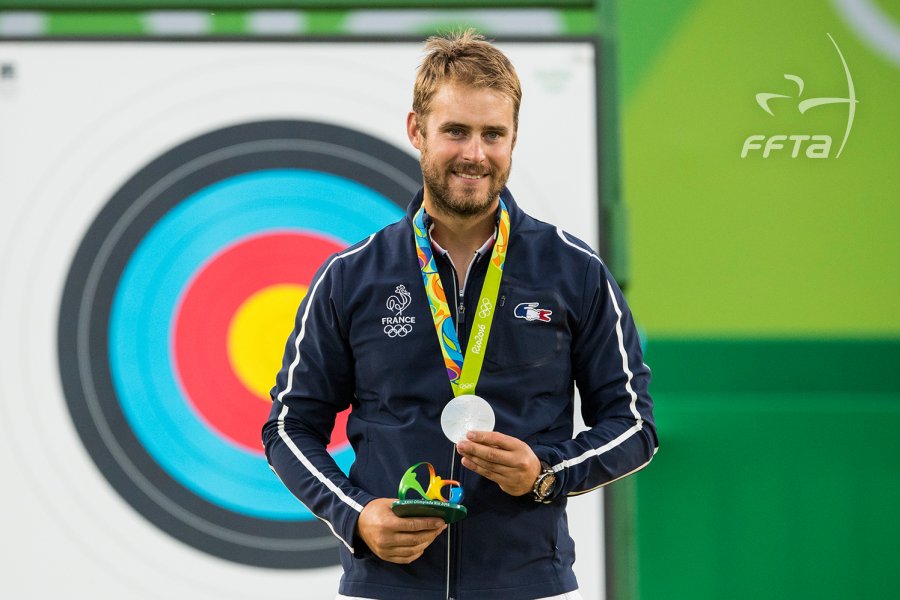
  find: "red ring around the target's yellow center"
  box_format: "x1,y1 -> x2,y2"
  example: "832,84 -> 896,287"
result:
173,232 -> 347,453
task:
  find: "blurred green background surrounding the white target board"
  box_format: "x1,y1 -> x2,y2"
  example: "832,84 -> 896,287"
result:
0,0 -> 900,600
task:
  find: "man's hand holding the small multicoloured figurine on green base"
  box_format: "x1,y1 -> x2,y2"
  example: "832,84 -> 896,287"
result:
356,498 -> 447,565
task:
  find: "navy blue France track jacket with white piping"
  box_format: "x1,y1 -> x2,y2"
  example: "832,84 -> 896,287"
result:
263,190 -> 657,600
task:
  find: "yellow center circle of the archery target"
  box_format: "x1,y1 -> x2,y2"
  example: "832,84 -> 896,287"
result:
228,284 -> 307,400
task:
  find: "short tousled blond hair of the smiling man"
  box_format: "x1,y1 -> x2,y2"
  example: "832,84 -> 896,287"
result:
413,29 -> 522,129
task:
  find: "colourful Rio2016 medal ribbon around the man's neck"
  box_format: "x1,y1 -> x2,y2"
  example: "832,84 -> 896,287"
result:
413,199 -> 509,396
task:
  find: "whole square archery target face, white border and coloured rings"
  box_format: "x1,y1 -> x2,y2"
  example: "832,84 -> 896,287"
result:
0,42 -> 597,598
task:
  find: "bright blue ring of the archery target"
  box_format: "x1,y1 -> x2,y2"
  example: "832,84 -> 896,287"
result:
109,170 -> 403,520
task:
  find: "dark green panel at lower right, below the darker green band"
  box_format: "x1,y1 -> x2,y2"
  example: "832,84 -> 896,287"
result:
636,392 -> 900,600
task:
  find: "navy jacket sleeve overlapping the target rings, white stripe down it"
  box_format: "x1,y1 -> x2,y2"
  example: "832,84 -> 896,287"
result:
262,247 -> 374,552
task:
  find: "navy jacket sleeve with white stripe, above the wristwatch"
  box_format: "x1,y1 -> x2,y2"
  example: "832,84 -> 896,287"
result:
534,250 -> 658,497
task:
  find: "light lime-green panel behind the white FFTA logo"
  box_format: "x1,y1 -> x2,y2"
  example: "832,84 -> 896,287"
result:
619,0 -> 900,337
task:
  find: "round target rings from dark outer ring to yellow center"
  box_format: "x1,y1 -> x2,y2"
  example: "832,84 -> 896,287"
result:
58,120 -> 421,569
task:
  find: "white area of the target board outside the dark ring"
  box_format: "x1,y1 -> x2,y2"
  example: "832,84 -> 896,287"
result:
0,42 -> 604,600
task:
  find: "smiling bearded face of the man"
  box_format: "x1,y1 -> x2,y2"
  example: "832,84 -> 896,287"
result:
407,83 -> 516,217
